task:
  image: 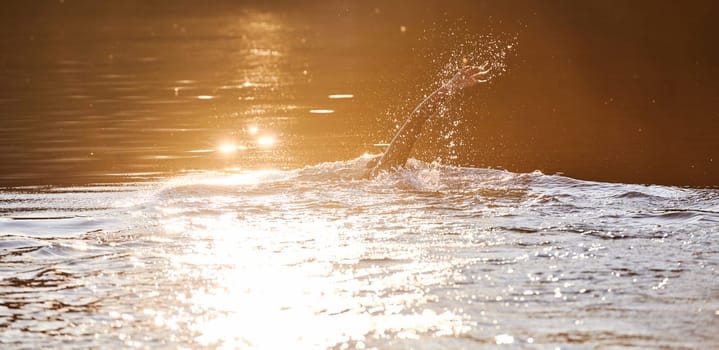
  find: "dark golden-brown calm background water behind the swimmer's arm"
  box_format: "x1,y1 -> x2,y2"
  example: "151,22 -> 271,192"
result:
0,1 -> 719,186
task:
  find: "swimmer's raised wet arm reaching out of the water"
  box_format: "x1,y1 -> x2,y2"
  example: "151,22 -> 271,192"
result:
367,62 -> 492,176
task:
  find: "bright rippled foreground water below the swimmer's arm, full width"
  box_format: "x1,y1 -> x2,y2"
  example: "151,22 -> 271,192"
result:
0,156 -> 719,349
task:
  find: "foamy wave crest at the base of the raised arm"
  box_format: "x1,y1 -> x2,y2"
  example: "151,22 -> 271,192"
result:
148,154 -> 551,199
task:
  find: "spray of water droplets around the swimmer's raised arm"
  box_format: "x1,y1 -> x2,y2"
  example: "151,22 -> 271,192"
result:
374,21 -> 519,164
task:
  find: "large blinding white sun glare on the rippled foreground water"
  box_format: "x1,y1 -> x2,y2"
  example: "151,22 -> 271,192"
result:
155,171 -> 474,349
